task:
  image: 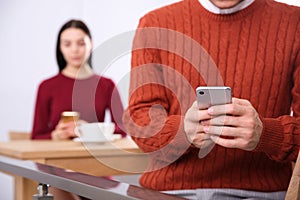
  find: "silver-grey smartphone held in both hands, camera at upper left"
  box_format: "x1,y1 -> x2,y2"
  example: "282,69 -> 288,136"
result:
196,86 -> 232,109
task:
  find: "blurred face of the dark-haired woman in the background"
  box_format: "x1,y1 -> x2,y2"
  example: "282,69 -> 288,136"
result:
60,28 -> 92,68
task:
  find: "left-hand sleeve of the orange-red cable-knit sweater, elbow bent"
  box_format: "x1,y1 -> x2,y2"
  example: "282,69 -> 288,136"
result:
123,13 -> 190,163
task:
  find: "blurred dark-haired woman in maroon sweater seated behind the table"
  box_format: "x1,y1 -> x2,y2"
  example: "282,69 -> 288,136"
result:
31,20 -> 126,140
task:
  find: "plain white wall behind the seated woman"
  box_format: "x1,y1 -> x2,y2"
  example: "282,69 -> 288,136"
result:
0,0 -> 300,200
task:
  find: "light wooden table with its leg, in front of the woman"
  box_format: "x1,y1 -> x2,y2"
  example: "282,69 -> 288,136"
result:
0,138 -> 149,200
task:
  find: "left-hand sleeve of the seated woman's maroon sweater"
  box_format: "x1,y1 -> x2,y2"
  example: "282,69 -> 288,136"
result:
31,83 -> 51,139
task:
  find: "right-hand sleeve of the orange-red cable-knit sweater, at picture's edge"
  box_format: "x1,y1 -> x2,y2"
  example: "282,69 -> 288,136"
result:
255,38 -> 300,161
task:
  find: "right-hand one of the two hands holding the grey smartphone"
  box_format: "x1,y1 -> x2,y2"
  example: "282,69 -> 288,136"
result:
201,98 -> 263,151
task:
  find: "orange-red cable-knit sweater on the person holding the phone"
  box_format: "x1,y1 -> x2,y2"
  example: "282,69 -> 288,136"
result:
123,0 -> 300,191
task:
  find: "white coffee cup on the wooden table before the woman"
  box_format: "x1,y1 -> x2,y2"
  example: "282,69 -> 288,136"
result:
75,122 -> 115,142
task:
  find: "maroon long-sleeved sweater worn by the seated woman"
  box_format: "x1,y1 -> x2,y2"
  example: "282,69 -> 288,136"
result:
32,73 -> 126,139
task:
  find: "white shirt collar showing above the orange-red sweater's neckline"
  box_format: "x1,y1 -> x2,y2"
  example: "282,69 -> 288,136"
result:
199,0 -> 254,14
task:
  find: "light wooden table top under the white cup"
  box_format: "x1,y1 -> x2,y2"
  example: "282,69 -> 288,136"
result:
0,138 -> 142,160
